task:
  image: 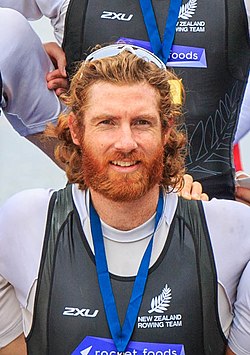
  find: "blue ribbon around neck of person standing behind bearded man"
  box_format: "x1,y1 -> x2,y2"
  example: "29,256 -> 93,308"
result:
140,0 -> 182,64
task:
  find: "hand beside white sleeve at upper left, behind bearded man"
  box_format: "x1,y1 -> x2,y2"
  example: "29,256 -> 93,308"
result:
43,42 -> 69,96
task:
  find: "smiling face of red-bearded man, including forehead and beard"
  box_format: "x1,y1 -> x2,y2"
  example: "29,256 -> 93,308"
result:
71,83 -> 169,201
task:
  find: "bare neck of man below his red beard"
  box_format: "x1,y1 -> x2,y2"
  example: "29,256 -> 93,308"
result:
90,186 -> 159,230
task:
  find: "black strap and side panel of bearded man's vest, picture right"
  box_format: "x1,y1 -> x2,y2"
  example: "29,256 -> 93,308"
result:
176,198 -> 227,354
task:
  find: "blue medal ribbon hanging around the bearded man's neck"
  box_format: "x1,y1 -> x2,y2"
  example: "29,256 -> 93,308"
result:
90,192 -> 163,352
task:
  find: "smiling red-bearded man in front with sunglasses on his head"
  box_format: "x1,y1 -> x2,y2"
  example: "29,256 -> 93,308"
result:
0,45 -> 250,355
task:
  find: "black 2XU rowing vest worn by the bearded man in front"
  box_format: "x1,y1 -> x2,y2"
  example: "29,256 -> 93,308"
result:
27,185 -> 226,355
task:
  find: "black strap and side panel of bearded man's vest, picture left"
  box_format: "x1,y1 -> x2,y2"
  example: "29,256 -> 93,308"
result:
26,184 -> 74,355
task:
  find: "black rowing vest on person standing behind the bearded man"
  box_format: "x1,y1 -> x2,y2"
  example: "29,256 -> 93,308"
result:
63,0 -> 250,199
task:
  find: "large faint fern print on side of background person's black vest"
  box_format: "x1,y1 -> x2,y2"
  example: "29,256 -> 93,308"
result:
183,83 -> 240,177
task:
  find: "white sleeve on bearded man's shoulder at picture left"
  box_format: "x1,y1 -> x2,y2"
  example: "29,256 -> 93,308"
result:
0,189 -> 56,304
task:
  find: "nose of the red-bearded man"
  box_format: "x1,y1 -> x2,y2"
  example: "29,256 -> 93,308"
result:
114,125 -> 138,152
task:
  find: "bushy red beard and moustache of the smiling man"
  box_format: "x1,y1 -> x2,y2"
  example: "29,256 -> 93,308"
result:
82,145 -> 163,202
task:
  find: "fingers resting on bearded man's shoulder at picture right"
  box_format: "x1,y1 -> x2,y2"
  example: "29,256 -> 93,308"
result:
178,174 -> 209,201
